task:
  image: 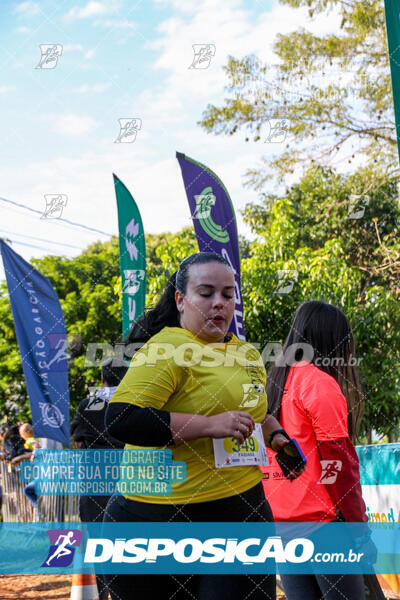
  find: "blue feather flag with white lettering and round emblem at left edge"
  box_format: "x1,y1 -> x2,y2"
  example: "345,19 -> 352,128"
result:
0,240 -> 70,447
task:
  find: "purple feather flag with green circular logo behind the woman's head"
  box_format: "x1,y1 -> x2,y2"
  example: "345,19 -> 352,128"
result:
176,152 -> 245,340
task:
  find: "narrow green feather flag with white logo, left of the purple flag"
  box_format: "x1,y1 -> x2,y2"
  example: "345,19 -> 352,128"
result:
114,174 -> 146,338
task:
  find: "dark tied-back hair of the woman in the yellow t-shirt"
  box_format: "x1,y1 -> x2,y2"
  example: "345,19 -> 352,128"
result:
125,252 -> 230,344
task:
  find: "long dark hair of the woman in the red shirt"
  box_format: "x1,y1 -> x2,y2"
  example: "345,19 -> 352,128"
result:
266,300 -> 362,440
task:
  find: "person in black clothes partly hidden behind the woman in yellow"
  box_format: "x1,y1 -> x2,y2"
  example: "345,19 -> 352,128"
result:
71,358 -> 128,600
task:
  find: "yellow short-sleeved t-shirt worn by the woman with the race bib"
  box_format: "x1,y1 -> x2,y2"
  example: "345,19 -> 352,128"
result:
110,327 -> 267,504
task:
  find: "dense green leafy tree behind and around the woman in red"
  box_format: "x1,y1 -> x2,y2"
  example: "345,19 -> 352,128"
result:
243,169 -> 400,435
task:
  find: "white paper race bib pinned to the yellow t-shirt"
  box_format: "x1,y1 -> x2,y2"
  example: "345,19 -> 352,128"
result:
213,423 -> 268,469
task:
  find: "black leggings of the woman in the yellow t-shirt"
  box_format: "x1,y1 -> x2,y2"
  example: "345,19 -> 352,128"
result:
104,483 -> 276,600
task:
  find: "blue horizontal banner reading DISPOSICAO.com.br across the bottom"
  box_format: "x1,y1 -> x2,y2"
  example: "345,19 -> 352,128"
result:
0,522 -> 400,575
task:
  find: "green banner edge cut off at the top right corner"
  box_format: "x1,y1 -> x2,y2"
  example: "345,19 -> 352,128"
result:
385,0 -> 400,164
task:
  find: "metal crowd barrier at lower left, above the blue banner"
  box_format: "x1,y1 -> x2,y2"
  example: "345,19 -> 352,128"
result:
0,461 -> 79,523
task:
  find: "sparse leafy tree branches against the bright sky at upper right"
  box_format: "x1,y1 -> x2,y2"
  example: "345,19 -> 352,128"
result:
200,0 -> 398,183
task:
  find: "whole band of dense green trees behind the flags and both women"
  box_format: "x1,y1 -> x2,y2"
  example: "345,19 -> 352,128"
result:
0,183 -> 400,433
